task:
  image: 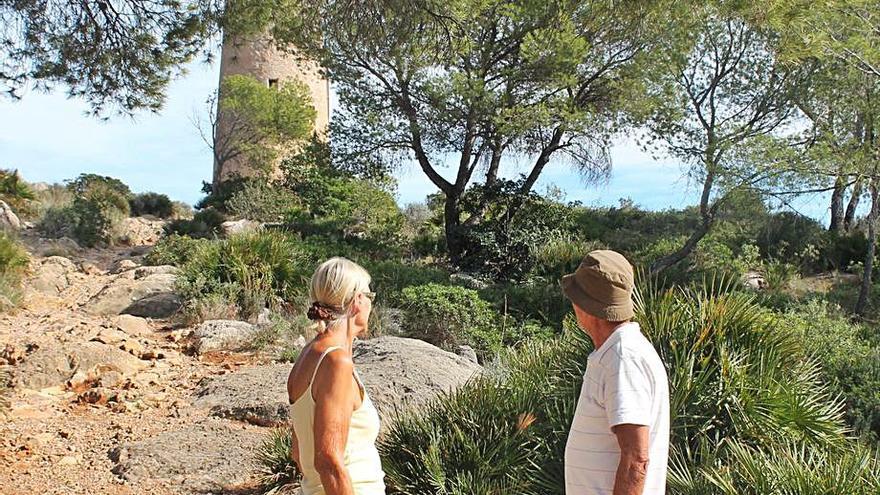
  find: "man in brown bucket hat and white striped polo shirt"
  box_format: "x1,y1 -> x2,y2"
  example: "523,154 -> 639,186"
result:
562,251 -> 669,495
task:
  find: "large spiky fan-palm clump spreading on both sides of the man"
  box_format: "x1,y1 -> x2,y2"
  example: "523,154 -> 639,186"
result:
379,280 -> 860,495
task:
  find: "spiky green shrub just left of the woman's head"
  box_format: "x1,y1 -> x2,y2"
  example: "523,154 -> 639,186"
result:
177,231 -> 311,319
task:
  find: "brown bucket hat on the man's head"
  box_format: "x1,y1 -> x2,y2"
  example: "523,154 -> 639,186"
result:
562,250 -> 635,321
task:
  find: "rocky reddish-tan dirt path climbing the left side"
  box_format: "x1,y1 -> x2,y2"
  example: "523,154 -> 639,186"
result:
0,238 -> 264,495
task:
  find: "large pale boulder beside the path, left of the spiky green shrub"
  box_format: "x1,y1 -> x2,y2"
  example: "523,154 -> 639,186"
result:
84,274 -> 177,316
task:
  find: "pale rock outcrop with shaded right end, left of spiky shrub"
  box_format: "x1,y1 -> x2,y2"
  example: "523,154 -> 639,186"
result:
84,273 -> 179,318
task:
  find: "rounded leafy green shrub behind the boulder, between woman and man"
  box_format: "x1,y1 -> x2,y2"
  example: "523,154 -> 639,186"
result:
401,283 -> 501,359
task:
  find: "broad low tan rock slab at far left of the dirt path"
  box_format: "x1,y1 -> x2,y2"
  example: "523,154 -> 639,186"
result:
16,342 -> 147,390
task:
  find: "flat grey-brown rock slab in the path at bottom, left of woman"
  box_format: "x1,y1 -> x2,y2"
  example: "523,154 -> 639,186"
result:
112,419 -> 266,493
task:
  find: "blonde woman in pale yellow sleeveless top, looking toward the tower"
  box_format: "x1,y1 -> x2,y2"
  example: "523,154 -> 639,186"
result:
287,258 -> 385,495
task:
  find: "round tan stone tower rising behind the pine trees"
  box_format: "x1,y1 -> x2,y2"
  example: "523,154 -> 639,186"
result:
214,38 -> 330,186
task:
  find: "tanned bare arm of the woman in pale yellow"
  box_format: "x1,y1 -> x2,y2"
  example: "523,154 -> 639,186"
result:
312,352 -> 355,495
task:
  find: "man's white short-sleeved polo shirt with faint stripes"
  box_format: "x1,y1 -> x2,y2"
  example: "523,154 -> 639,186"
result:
565,323 -> 669,495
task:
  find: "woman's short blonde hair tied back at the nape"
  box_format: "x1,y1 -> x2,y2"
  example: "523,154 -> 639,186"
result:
309,257 -> 371,333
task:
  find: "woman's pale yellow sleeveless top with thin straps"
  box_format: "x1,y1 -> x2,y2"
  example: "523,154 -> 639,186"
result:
290,347 -> 385,495
